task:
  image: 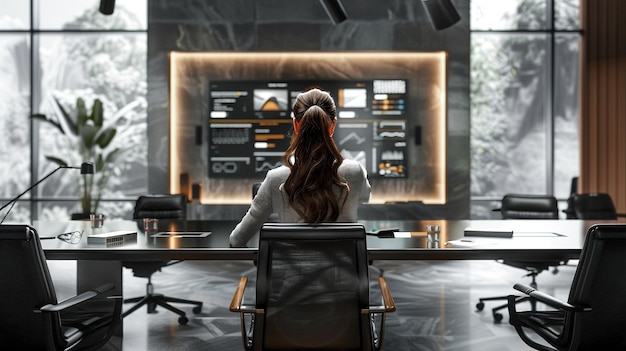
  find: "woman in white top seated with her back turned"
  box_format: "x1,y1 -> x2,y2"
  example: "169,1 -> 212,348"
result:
230,89 -> 371,247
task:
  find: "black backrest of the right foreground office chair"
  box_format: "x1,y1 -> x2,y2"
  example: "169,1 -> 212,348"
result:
563,224 -> 626,350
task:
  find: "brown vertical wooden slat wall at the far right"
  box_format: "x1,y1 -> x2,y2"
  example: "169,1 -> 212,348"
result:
579,0 -> 626,213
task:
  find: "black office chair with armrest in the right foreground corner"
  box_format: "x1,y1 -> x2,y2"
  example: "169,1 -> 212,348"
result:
508,224 -> 626,351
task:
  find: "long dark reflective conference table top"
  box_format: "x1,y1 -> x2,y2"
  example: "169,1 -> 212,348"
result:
33,220 -> 615,261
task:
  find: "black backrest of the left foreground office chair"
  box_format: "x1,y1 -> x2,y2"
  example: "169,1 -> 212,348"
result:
0,225 -> 59,350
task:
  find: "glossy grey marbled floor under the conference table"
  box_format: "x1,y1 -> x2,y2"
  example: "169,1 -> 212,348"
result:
49,261 -> 575,351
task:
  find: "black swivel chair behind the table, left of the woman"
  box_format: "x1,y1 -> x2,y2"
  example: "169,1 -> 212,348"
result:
122,194 -> 202,324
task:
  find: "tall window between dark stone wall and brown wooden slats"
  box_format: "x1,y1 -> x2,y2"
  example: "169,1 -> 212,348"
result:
470,0 -> 580,218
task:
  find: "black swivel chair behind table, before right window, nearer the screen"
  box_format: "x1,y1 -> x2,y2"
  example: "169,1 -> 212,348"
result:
476,194 -> 566,323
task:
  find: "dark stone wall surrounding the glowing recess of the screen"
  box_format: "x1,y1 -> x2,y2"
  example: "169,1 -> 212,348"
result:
148,0 -> 470,218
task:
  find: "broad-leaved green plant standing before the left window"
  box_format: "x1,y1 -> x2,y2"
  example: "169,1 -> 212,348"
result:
32,97 -> 120,219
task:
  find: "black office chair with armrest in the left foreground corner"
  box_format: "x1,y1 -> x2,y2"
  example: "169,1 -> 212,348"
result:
0,225 -> 122,350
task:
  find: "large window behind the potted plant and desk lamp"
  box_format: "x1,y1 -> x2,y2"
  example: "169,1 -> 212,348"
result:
0,0 -> 147,222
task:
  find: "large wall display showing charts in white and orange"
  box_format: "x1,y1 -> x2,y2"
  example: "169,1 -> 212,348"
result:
208,79 -> 408,179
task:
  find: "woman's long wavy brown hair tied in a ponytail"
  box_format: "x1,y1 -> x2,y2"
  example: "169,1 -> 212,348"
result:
283,89 -> 349,223
